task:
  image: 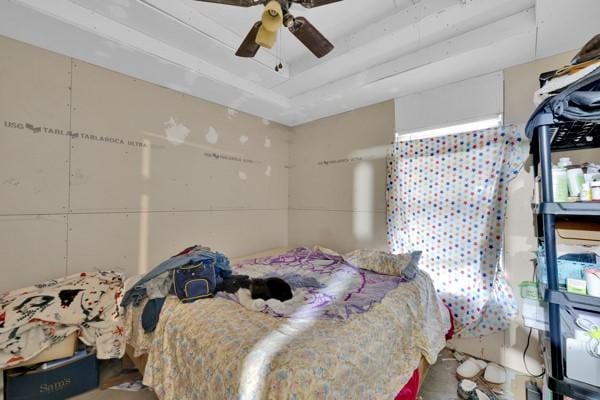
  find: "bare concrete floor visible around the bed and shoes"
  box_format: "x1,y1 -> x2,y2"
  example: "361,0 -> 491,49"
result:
74,350 -> 528,400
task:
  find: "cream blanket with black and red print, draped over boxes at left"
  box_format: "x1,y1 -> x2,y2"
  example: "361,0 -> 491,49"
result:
0,272 -> 125,369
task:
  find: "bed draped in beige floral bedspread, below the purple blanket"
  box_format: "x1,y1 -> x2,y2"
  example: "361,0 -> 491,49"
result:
125,249 -> 452,400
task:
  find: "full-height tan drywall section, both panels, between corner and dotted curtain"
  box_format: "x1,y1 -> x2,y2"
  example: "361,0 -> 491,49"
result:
289,101 -> 394,251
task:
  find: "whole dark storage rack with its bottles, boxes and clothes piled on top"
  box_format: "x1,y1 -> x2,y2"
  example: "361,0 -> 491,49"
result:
525,39 -> 600,400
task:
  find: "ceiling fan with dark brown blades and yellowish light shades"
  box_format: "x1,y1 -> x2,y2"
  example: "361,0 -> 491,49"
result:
197,0 -> 341,58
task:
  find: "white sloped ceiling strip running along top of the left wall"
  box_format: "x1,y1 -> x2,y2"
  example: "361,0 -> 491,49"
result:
0,1 -> 289,126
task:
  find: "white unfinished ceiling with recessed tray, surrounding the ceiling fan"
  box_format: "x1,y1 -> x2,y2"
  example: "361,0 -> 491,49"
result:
0,0 -> 600,126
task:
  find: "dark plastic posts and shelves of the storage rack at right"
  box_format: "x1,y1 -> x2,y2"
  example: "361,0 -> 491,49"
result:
532,113 -> 600,400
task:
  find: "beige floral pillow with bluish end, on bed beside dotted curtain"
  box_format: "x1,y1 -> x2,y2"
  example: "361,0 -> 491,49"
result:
344,249 -> 421,280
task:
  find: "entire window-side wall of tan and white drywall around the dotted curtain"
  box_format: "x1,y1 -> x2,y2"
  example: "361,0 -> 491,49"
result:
289,52 -> 600,373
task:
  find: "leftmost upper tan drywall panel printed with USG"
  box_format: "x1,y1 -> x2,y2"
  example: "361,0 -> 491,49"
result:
0,37 -> 70,214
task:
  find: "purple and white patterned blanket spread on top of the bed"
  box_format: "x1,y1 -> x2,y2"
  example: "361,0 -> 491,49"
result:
220,248 -> 405,320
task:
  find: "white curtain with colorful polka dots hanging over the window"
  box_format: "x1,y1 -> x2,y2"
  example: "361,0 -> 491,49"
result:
386,128 -> 529,337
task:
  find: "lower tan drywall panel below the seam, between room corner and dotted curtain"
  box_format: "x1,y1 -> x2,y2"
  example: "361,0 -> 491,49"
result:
289,210 -> 387,253
